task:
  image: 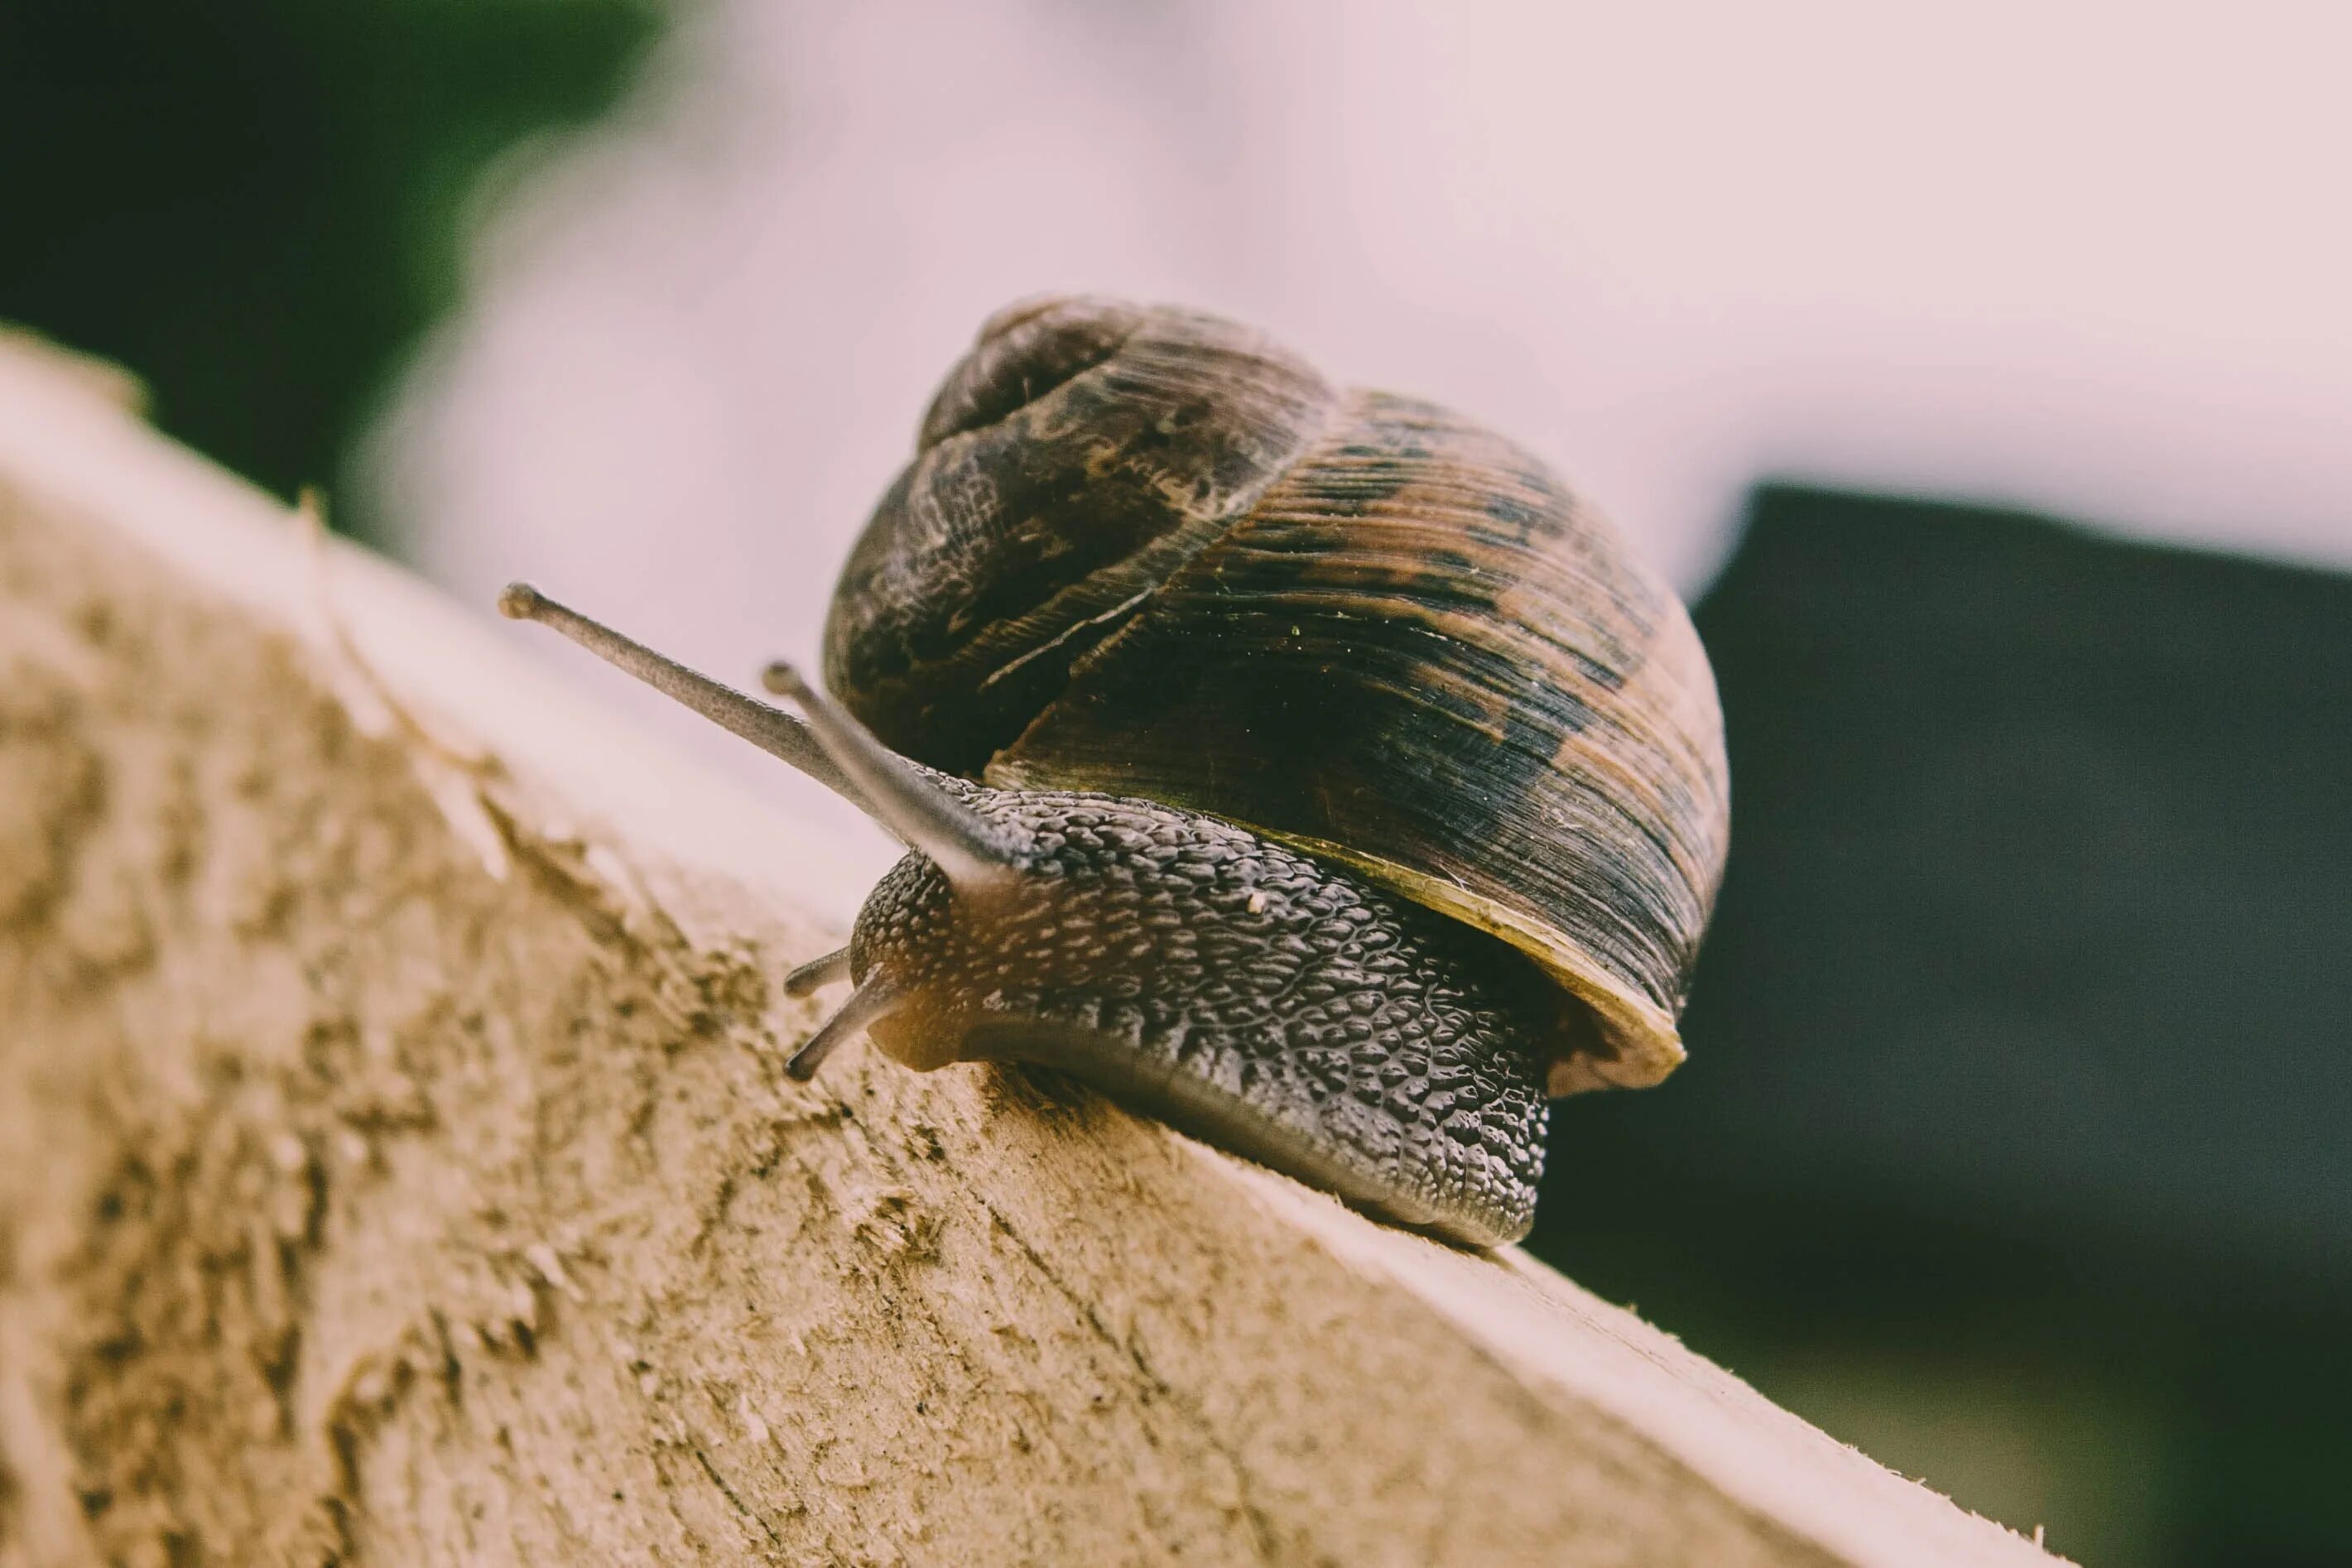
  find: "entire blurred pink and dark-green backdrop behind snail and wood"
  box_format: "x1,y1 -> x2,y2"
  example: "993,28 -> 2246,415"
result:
0,0 -> 2352,1566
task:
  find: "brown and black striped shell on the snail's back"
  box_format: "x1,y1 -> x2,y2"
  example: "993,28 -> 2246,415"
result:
825,299 -> 1729,1095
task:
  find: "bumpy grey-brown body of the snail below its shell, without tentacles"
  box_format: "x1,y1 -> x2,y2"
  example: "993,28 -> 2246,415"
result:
849,781 -> 1557,1246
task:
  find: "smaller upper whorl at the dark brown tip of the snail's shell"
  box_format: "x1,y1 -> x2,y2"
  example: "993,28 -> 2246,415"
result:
825,299 -> 1336,773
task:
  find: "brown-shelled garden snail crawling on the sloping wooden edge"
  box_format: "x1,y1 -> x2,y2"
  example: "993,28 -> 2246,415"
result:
501,296 -> 1729,1246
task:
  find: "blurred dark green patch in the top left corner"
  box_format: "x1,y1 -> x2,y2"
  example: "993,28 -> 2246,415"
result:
0,0 -> 657,533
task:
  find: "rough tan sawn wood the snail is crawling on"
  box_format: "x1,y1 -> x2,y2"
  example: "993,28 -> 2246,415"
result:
0,345 -> 2049,1566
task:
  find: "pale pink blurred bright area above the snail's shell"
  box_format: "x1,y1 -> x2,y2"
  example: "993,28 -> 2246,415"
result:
364,0 -> 2352,863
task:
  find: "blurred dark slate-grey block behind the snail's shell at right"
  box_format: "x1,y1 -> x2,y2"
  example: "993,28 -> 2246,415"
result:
1691,489 -> 2352,1260
